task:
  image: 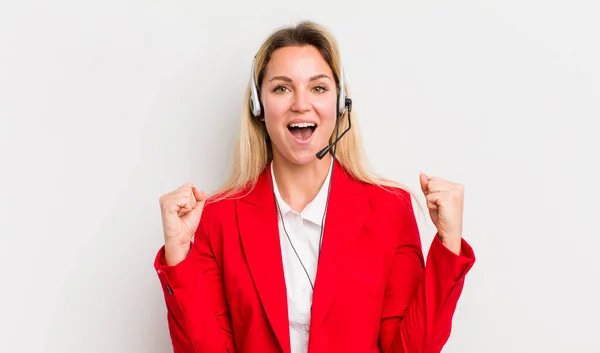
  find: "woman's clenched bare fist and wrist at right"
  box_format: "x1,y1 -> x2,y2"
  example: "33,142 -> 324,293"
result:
419,173 -> 464,255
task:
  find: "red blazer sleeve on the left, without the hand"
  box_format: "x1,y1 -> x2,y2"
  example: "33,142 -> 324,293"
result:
154,205 -> 235,353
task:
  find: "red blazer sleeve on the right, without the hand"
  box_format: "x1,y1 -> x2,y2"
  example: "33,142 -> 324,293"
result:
379,196 -> 475,353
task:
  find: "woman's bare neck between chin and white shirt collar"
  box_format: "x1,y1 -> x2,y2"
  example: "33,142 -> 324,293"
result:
273,154 -> 333,212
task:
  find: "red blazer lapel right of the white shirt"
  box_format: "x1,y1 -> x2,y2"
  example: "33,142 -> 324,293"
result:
311,161 -> 365,332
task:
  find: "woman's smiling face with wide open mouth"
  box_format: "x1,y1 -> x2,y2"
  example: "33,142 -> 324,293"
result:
261,45 -> 337,165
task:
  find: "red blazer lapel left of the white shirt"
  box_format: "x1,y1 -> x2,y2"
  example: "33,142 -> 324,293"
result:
236,168 -> 290,353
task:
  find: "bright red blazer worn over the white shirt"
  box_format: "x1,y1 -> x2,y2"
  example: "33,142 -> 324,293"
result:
154,162 -> 475,353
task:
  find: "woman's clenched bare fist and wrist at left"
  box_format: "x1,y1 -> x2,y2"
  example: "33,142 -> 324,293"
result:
159,183 -> 206,266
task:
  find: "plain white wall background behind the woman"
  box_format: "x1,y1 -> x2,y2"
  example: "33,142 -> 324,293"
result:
0,0 -> 600,353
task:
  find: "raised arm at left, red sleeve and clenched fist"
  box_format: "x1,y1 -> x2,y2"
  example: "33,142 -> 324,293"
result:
154,184 -> 235,353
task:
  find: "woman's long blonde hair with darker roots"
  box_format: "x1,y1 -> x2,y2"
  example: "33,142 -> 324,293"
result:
209,21 -> 422,214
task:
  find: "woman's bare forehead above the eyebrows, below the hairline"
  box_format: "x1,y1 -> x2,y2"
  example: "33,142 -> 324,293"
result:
265,45 -> 332,80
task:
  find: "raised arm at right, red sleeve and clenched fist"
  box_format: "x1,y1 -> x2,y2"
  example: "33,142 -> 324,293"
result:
380,174 -> 475,353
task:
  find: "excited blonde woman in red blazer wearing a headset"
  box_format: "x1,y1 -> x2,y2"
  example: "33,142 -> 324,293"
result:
155,22 -> 474,353
